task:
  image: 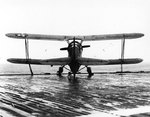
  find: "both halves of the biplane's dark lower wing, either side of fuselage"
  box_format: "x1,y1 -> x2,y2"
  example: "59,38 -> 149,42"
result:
7,57 -> 143,66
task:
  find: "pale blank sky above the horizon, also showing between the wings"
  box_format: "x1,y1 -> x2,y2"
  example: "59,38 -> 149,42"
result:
0,0 -> 150,63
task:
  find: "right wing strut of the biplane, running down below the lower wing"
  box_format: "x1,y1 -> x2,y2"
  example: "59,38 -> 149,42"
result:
121,35 -> 125,73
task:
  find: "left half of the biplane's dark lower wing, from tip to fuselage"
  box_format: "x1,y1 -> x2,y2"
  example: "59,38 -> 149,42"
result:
7,57 -> 70,65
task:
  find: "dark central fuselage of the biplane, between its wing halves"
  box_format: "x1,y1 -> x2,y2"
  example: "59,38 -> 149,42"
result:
68,40 -> 83,74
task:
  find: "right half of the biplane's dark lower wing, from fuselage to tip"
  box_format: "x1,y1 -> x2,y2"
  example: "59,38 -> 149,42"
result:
78,58 -> 143,65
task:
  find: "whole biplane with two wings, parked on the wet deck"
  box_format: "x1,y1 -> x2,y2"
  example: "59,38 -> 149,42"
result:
6,33 -> 144,79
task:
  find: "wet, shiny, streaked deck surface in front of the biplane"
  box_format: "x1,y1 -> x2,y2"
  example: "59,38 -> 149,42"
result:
0,73 -> 150,117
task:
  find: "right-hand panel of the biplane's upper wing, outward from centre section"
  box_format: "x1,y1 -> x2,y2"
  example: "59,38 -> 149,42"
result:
84,33 -> 144,41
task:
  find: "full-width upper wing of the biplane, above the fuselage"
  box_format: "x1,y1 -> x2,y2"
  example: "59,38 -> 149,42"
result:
6,33 -> 144,41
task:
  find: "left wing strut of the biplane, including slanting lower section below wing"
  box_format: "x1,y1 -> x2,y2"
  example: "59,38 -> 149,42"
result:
25,37 -> 33,75
